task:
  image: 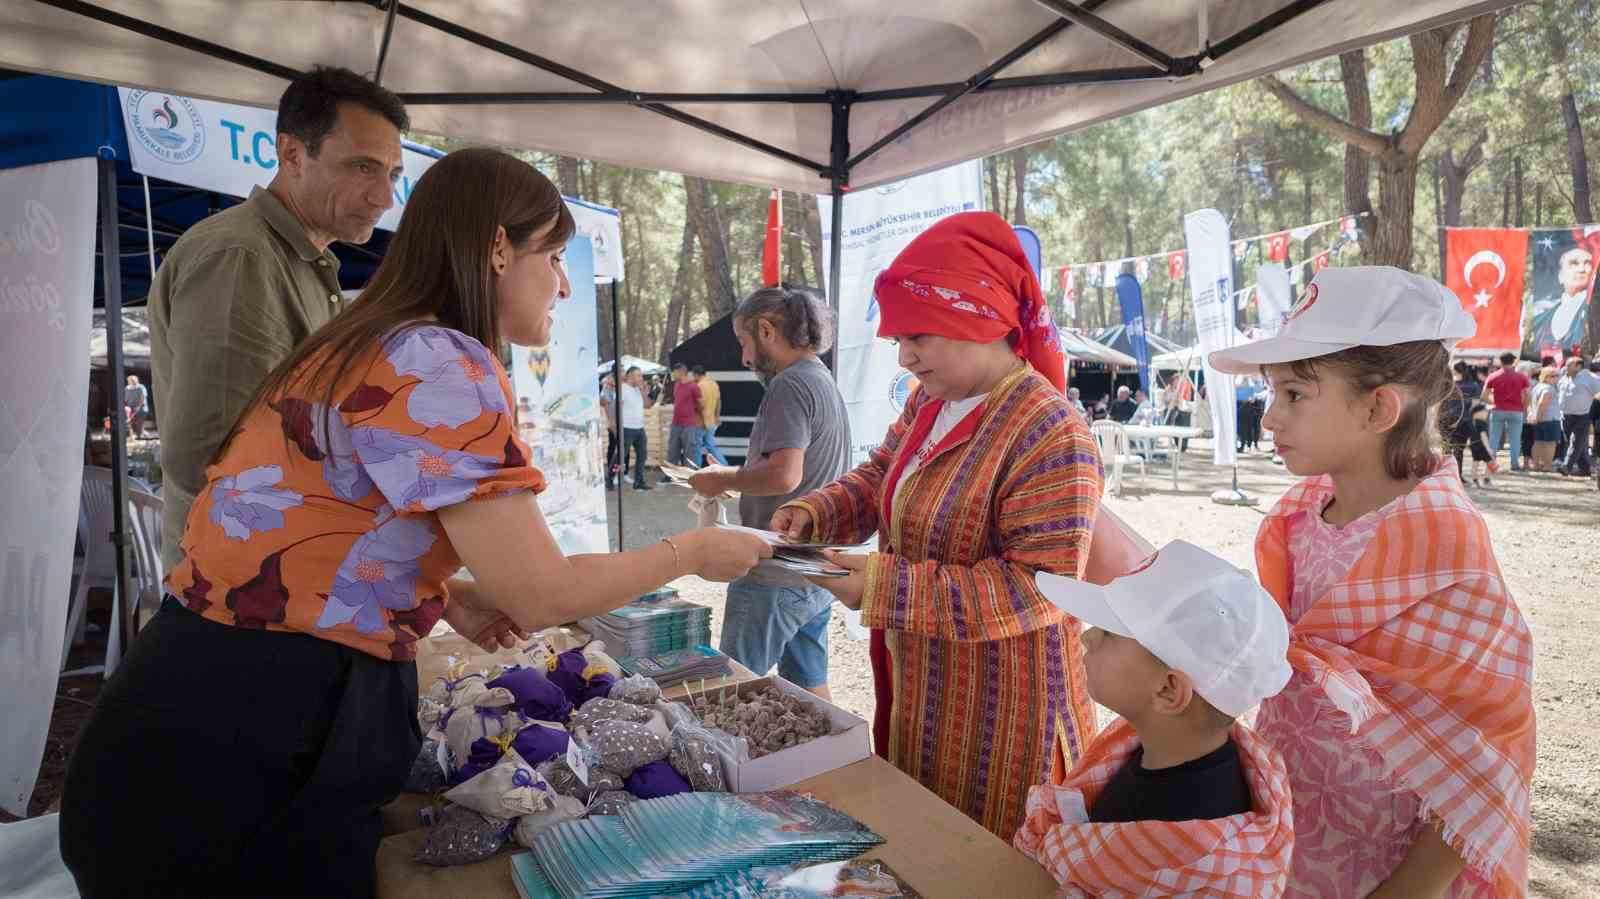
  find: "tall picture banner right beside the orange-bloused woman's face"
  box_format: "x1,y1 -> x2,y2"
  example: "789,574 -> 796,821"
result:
510,235 -> 611,555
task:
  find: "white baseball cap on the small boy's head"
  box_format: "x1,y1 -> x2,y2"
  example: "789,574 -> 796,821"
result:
1035,541 -> 1290,717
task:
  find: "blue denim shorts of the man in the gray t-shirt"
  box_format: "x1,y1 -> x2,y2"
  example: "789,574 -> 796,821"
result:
720,577 -> 834,688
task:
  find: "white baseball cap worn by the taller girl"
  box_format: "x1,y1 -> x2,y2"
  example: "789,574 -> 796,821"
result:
1208,266 -> 1478,374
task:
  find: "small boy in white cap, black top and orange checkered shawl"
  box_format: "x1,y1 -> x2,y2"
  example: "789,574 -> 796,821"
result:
1014,541 -> 1294,896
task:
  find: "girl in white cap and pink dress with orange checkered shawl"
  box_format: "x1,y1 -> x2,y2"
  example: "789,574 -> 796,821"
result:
1211,267 -> 1534,897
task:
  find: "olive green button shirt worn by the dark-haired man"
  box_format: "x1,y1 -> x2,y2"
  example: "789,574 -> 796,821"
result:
150,187 -> 342,569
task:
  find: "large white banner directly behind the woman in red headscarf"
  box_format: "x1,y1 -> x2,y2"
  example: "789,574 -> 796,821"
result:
818,160 -> 984,465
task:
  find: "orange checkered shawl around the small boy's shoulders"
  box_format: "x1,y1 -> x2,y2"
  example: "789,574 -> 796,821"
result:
1013,718 -> 1294,899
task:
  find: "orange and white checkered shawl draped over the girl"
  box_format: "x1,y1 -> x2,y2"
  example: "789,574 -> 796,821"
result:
1256,462 -> 1534,896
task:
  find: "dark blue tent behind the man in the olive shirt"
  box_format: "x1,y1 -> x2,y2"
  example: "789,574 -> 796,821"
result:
0,75 -> 443,307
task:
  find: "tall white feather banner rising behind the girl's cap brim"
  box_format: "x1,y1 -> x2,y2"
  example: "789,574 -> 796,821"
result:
1184,210 -> 1238,465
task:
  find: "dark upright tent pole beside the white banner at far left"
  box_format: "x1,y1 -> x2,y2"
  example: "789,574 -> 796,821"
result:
90,158 -> 138,649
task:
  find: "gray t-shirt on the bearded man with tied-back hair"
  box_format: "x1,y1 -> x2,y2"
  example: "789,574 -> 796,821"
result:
739,358 -> 850,528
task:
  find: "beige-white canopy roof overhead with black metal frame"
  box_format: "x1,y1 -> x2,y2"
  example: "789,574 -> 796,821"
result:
0,0 -> 1510,194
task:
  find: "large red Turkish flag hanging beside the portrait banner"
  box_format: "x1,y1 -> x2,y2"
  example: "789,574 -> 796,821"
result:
1445,227 -> 1528,352
